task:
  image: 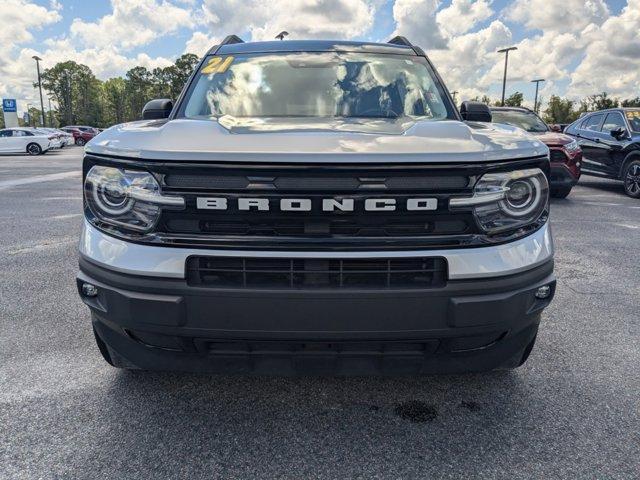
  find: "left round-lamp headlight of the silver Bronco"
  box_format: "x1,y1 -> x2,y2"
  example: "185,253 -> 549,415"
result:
84,165 -> 184,232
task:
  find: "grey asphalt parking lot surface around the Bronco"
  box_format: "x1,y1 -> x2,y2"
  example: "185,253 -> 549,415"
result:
0,147 -> 640,479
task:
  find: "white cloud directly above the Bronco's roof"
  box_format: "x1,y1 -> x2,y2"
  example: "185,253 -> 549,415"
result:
202,0 -> 375,40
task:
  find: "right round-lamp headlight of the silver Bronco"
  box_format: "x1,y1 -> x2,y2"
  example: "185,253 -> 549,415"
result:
450,168 -> 549,235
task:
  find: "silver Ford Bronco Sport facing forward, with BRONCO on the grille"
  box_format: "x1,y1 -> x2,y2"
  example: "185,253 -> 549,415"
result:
77,36 -> 555,375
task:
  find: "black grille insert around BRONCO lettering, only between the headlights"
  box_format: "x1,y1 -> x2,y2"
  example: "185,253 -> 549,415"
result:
158,165 -> 480,249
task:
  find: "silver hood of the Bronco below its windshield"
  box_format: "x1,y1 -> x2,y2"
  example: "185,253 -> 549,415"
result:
86,117 -> 548,163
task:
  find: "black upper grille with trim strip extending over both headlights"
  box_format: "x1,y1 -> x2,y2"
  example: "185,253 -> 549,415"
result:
83,153 -> 553,252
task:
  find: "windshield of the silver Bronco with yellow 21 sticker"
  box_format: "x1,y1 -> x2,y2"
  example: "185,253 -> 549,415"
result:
182,52 -> 455,120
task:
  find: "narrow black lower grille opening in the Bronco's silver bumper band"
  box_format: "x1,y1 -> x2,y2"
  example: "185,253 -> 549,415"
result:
187,257 -> 447,289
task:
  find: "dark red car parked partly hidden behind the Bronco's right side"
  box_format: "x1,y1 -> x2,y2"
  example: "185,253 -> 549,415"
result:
491,107 -> 582,198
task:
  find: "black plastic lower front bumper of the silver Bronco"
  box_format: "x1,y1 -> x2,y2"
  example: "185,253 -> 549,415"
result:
77,228 -> 555,374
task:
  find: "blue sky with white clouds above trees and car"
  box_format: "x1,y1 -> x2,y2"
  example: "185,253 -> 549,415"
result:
0,0 -> 640,113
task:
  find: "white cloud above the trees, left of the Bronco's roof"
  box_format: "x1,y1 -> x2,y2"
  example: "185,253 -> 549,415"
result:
70,0 -> 195,49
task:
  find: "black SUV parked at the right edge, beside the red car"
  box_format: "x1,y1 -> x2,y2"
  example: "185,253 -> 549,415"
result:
565,108 -> 640,198
